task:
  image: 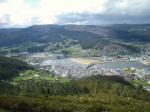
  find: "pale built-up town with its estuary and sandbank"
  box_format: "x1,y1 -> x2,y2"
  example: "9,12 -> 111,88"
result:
13,52 -> 150,90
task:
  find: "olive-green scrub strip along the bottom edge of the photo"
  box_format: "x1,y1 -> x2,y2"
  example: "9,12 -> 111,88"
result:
0,93 -> 150,112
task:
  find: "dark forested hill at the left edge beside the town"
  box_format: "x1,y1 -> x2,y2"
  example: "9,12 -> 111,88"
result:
0,56 -> 32,80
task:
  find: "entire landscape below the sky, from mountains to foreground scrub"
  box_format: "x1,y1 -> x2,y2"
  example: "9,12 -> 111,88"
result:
0,24 -> 150,112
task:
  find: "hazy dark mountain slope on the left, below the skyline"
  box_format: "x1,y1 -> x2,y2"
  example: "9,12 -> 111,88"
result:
0,25 -> 101,46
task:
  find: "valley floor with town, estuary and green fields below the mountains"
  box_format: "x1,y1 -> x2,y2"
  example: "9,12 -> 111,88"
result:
0,40 -> 150,90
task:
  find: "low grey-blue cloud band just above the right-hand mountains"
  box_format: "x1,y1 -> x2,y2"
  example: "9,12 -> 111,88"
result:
56,13 -> 150,25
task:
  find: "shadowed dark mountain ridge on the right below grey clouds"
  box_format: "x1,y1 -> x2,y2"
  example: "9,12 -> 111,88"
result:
64,24 -> 150,41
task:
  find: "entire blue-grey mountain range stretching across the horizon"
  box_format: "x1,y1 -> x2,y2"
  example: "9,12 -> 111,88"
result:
0,24 -> 150,46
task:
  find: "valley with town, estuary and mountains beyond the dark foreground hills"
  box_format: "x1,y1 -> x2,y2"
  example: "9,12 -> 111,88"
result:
0,24 -> 150,90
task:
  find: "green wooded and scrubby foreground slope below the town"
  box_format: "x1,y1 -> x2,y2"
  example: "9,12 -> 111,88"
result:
0,57 -> 150,112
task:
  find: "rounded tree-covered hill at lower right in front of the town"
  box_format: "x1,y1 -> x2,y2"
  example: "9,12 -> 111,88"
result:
77,75 -> 150,101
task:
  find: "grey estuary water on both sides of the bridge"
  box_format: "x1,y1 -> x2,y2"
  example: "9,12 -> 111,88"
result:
41,58 -> 150,69
